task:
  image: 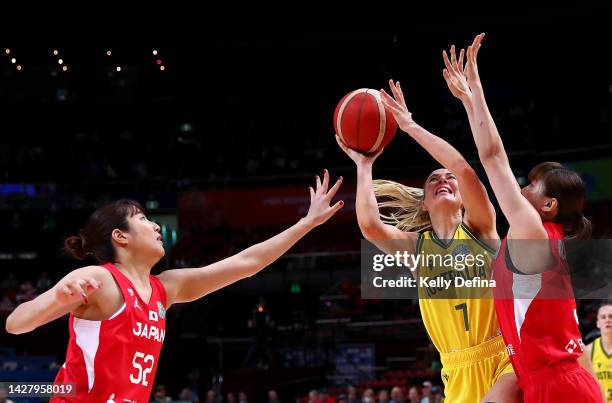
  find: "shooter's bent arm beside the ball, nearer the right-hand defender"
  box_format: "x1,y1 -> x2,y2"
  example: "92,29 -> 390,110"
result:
380,79 -> 498,239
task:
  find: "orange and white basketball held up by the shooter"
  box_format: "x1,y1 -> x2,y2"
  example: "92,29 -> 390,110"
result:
334,88 -> 397,154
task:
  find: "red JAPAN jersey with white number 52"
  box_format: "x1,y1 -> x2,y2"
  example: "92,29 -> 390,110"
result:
51,263 -> 166,403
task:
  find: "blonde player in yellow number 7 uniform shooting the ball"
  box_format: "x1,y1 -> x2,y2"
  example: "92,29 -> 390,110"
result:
336,81 -> 520,403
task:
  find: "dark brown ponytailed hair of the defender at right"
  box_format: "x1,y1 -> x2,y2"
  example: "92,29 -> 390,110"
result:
529,162 -> 592,239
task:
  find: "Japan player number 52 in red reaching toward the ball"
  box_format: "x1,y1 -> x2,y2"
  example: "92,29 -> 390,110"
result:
6,170 -> 344,403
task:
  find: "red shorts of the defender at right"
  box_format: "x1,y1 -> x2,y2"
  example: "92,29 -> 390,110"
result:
520,361 -> 602,403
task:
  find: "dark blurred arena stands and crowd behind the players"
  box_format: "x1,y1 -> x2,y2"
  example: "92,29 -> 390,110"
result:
0,2 -> 612,403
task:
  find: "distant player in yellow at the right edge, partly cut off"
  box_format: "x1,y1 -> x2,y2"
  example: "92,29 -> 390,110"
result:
580,303 -> 612,403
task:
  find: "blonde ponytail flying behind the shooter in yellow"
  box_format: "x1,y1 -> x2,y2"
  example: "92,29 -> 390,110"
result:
373,179 -> 431,232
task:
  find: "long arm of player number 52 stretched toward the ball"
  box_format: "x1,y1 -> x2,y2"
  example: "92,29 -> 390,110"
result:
159,170 -> 344,306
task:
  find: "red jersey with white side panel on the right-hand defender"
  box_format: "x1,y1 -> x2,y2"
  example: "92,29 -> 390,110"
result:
493,222 -> 584,385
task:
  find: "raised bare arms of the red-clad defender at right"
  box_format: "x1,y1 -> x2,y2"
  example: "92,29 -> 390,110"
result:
443,34 -> 548,239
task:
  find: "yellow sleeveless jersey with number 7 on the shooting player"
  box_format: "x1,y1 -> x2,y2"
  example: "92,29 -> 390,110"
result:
417,223 -> 500,353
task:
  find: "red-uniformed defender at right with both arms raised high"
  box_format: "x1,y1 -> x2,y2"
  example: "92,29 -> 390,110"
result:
443,34 -> 603,403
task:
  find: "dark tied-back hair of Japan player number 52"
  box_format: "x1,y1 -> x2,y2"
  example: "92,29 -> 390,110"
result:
64,199 -> 144,263
